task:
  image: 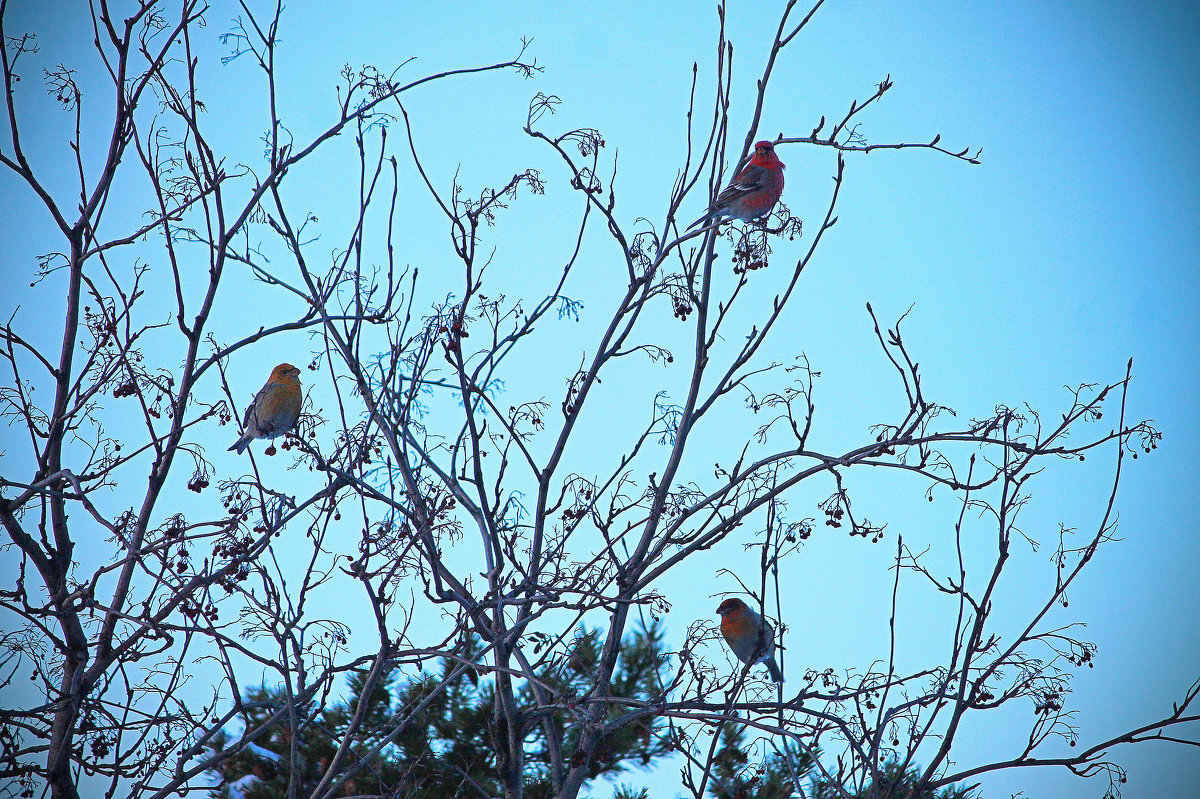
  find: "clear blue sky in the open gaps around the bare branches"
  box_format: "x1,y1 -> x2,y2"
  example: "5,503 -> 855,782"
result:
0,0 -> 1200,799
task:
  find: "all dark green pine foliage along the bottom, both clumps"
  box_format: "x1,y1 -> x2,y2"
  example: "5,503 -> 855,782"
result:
212,625 -> 976,799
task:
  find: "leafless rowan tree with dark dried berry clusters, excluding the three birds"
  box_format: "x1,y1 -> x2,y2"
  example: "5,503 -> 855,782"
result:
0,0 -> 1200,799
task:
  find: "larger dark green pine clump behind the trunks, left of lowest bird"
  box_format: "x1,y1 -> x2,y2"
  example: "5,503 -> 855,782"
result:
212,624 -> 672,799
